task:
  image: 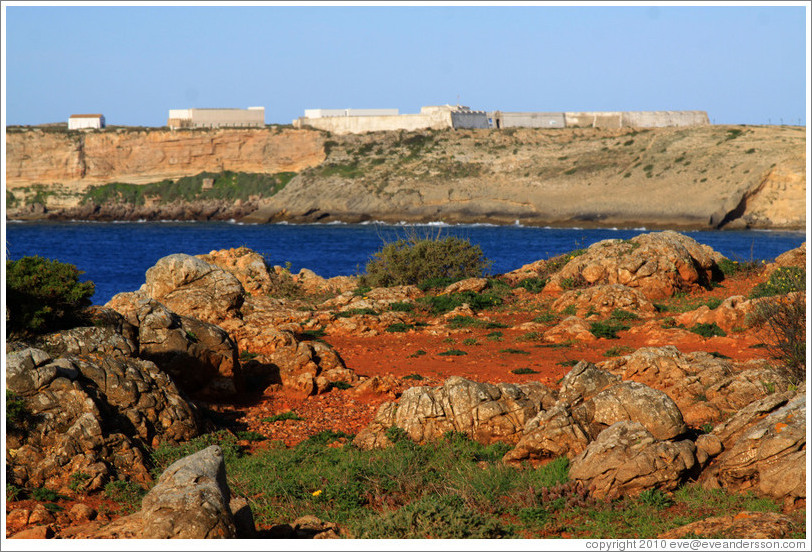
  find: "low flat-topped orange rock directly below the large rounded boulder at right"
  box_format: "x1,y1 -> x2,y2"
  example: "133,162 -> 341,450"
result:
551,284 -> 657,318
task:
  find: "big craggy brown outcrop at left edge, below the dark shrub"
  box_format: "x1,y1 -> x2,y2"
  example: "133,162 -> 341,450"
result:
6,338 -> 201,490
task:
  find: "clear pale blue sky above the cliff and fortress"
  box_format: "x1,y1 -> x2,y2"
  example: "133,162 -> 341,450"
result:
3,2 -> 809,126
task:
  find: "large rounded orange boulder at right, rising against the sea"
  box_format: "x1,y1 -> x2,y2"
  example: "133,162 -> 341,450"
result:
544,231 -> 722,300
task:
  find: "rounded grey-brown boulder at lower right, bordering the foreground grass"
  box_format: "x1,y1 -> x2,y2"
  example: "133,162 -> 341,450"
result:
569,421 -> 696,499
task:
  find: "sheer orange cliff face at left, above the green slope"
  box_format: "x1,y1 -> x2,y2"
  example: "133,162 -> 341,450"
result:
6,129 -> 324,189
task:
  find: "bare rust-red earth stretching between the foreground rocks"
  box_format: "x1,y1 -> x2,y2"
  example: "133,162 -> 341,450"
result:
227,275 -> 769,447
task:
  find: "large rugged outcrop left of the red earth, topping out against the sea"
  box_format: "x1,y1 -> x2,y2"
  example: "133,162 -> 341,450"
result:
107,248 -> 358,397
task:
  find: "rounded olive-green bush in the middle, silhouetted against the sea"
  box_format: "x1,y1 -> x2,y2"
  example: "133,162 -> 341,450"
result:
361,236 -> 491,287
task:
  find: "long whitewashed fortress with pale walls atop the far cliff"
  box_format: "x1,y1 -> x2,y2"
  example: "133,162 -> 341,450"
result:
293,105 -> 710,134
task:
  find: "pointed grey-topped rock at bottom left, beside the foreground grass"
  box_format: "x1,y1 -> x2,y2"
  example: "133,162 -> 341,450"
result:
93,445 -> 249,539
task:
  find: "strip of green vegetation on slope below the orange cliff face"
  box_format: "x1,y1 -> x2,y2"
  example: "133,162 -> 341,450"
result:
82,171 -> 296,205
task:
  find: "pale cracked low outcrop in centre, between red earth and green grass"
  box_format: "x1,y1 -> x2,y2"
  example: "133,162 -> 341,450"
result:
353,376 -> 554,448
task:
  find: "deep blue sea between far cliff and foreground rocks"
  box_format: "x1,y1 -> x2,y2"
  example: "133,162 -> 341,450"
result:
5,222 -> 806,304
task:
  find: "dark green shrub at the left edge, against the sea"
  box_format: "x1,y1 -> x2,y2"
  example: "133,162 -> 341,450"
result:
6,256 -> 95,335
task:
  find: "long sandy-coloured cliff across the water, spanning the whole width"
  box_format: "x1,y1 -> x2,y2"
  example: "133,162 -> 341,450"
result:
6,126 -> 806,228
